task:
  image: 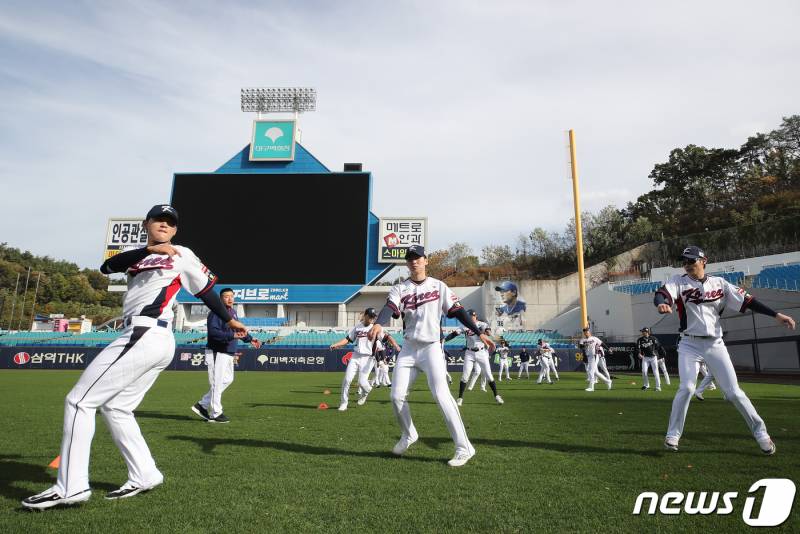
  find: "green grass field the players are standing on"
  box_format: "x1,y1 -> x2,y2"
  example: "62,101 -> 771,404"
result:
0,370 -> 800,533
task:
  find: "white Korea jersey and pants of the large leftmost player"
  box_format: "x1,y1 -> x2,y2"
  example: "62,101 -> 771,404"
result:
55,246 -> 216,497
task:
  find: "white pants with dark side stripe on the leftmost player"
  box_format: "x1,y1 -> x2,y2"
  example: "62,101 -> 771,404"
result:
56,319 -> 175,497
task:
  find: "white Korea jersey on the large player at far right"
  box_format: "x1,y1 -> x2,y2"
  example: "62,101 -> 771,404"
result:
657,274 -> 753,337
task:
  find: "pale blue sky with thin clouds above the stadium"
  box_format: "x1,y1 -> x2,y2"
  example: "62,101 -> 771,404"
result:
0,1 -> 800,266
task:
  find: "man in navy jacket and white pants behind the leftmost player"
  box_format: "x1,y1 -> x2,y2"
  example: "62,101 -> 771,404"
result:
192,287 -> 261,423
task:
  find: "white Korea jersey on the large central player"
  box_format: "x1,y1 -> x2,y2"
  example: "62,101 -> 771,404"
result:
386,277 -> 461,343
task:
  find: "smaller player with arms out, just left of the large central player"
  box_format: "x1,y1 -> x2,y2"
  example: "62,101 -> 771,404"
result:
330,308 -> 400,412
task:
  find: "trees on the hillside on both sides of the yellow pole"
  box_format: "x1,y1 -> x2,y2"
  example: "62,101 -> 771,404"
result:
429,115 -> 800,285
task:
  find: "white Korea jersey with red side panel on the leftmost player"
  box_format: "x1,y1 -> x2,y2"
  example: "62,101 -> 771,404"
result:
122,246 -> 217,321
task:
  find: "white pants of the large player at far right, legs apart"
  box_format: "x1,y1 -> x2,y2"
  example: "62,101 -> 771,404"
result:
667,337 -> 769,439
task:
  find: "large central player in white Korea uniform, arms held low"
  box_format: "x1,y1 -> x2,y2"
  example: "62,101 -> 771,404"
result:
369,245 -> 494,467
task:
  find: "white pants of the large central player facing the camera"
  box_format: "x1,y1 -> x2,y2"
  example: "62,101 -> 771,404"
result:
391,340 -> 472,454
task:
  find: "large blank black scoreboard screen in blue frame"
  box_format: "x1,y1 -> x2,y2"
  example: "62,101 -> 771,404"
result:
172,172 -> 370,285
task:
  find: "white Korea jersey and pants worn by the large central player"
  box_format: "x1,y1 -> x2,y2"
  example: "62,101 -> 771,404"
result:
387,277 -> 475,455
